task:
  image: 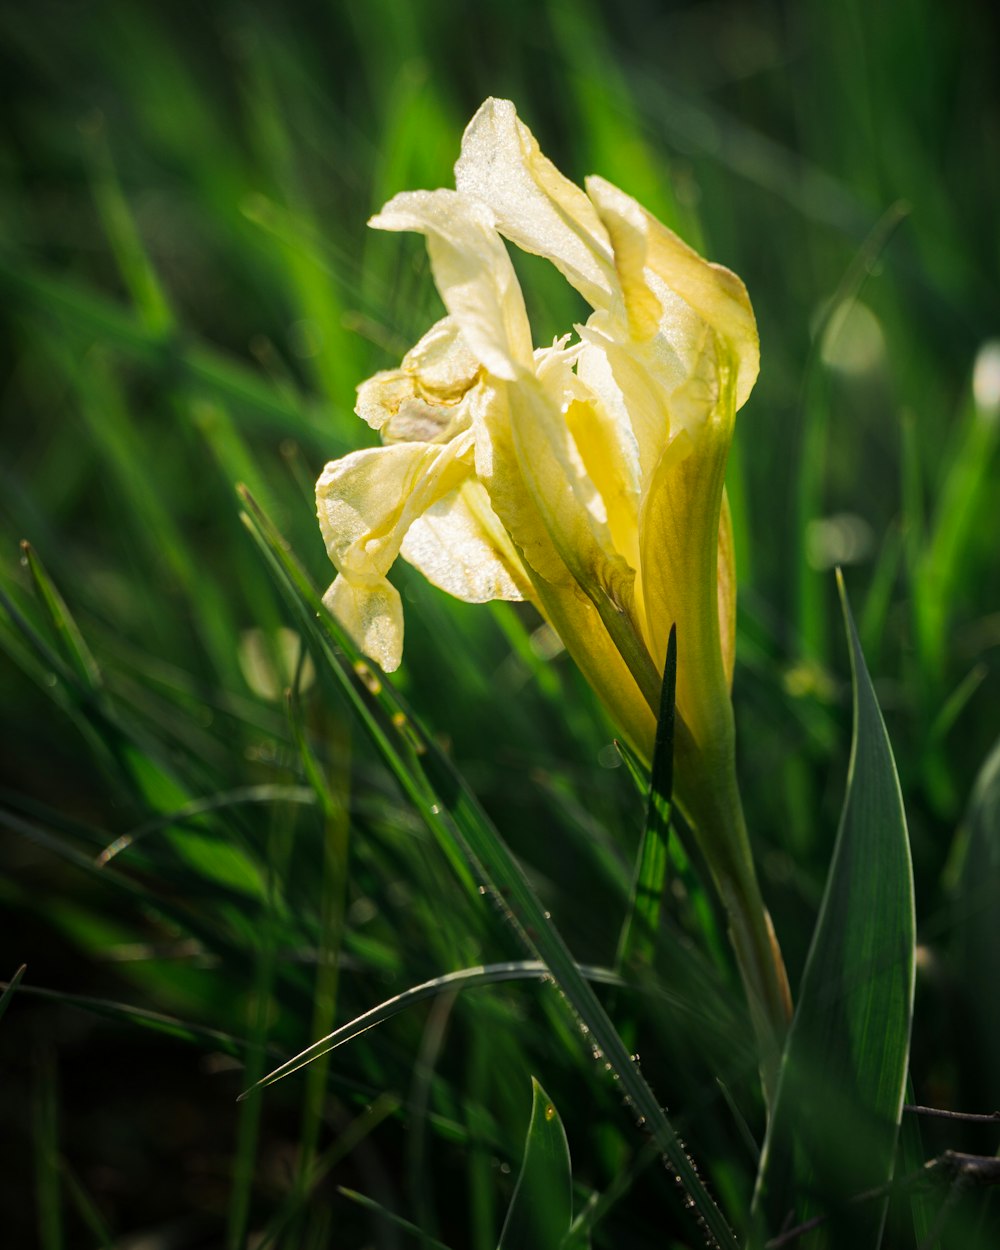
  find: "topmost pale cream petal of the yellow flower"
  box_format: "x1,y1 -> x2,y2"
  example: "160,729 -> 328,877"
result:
455,99 -> 618,308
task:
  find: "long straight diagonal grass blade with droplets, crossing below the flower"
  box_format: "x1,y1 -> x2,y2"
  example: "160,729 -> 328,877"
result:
240,489 -> 736,1248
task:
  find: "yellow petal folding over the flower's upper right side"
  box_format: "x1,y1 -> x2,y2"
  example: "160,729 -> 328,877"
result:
586,178 -> 760,409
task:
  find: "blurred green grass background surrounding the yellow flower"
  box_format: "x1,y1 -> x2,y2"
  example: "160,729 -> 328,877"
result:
0,0 -> 1000,1250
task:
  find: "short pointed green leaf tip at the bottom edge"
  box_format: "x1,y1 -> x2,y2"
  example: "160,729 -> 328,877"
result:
496,1076 -> 573,1250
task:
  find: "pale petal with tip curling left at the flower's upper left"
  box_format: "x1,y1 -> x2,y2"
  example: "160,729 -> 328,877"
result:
369,190 -> 531,379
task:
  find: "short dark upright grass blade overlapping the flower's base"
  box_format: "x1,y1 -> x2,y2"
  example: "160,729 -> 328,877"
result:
615,626 -> 678,970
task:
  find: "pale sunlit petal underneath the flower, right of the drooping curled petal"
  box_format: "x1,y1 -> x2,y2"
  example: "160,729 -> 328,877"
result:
400,479 -> 530,604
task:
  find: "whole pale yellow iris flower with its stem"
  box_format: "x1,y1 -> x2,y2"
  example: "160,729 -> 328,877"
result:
318,100 -> 785,1085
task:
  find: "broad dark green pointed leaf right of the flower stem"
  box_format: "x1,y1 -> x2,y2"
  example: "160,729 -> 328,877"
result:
754,579 -> 915,1248
